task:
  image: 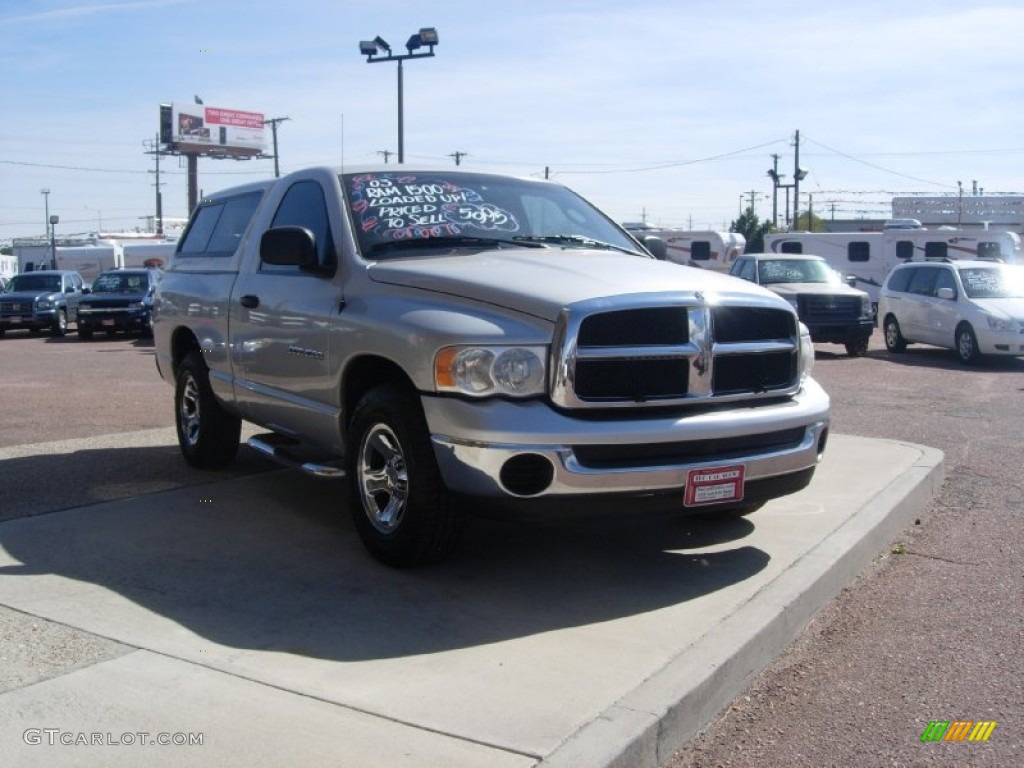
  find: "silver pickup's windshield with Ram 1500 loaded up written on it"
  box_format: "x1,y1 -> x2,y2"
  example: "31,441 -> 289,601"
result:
341,170 -> 646,259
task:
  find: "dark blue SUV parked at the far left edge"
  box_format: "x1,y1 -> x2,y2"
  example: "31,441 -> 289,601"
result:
0,269 -> 89,336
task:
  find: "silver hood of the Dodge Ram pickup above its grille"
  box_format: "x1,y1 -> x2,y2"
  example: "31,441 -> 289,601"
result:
368,248 -> 777,323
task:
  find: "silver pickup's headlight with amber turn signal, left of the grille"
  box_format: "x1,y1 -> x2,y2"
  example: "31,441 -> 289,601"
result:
434,346 -> 547,397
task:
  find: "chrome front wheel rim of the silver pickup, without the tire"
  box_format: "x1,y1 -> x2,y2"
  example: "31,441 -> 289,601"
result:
356,424 -> 409,534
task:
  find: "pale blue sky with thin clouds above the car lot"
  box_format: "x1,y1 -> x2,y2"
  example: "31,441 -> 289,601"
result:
0,0 -> 1024,243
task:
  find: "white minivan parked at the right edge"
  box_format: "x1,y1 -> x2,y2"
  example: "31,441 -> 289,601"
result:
879,261 -> 1024,365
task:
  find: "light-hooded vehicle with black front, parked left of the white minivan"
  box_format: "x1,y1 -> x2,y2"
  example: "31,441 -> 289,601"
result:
729,253 -> 874,357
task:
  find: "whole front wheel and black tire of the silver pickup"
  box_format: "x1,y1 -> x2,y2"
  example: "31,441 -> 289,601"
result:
348,384 -> 463,567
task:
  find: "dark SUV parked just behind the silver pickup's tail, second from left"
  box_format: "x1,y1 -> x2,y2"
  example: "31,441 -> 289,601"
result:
78,268 -> 160,341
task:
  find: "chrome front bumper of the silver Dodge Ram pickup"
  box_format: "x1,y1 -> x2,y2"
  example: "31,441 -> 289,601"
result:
423,380 -> 829,499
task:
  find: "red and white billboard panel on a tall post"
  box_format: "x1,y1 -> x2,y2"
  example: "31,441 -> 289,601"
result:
161,102 -> 265,156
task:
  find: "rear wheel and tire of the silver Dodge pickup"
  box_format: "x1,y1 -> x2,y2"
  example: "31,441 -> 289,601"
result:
174,352 -> 242,469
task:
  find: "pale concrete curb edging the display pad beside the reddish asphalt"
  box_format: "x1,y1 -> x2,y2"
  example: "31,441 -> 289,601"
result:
538,440 -> 944,768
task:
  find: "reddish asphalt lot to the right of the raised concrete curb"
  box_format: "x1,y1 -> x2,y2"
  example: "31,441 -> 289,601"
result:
663,333 -> 1024,768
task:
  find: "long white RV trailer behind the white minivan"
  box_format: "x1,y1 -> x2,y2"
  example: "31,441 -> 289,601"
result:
765,227 -> 1024,304
